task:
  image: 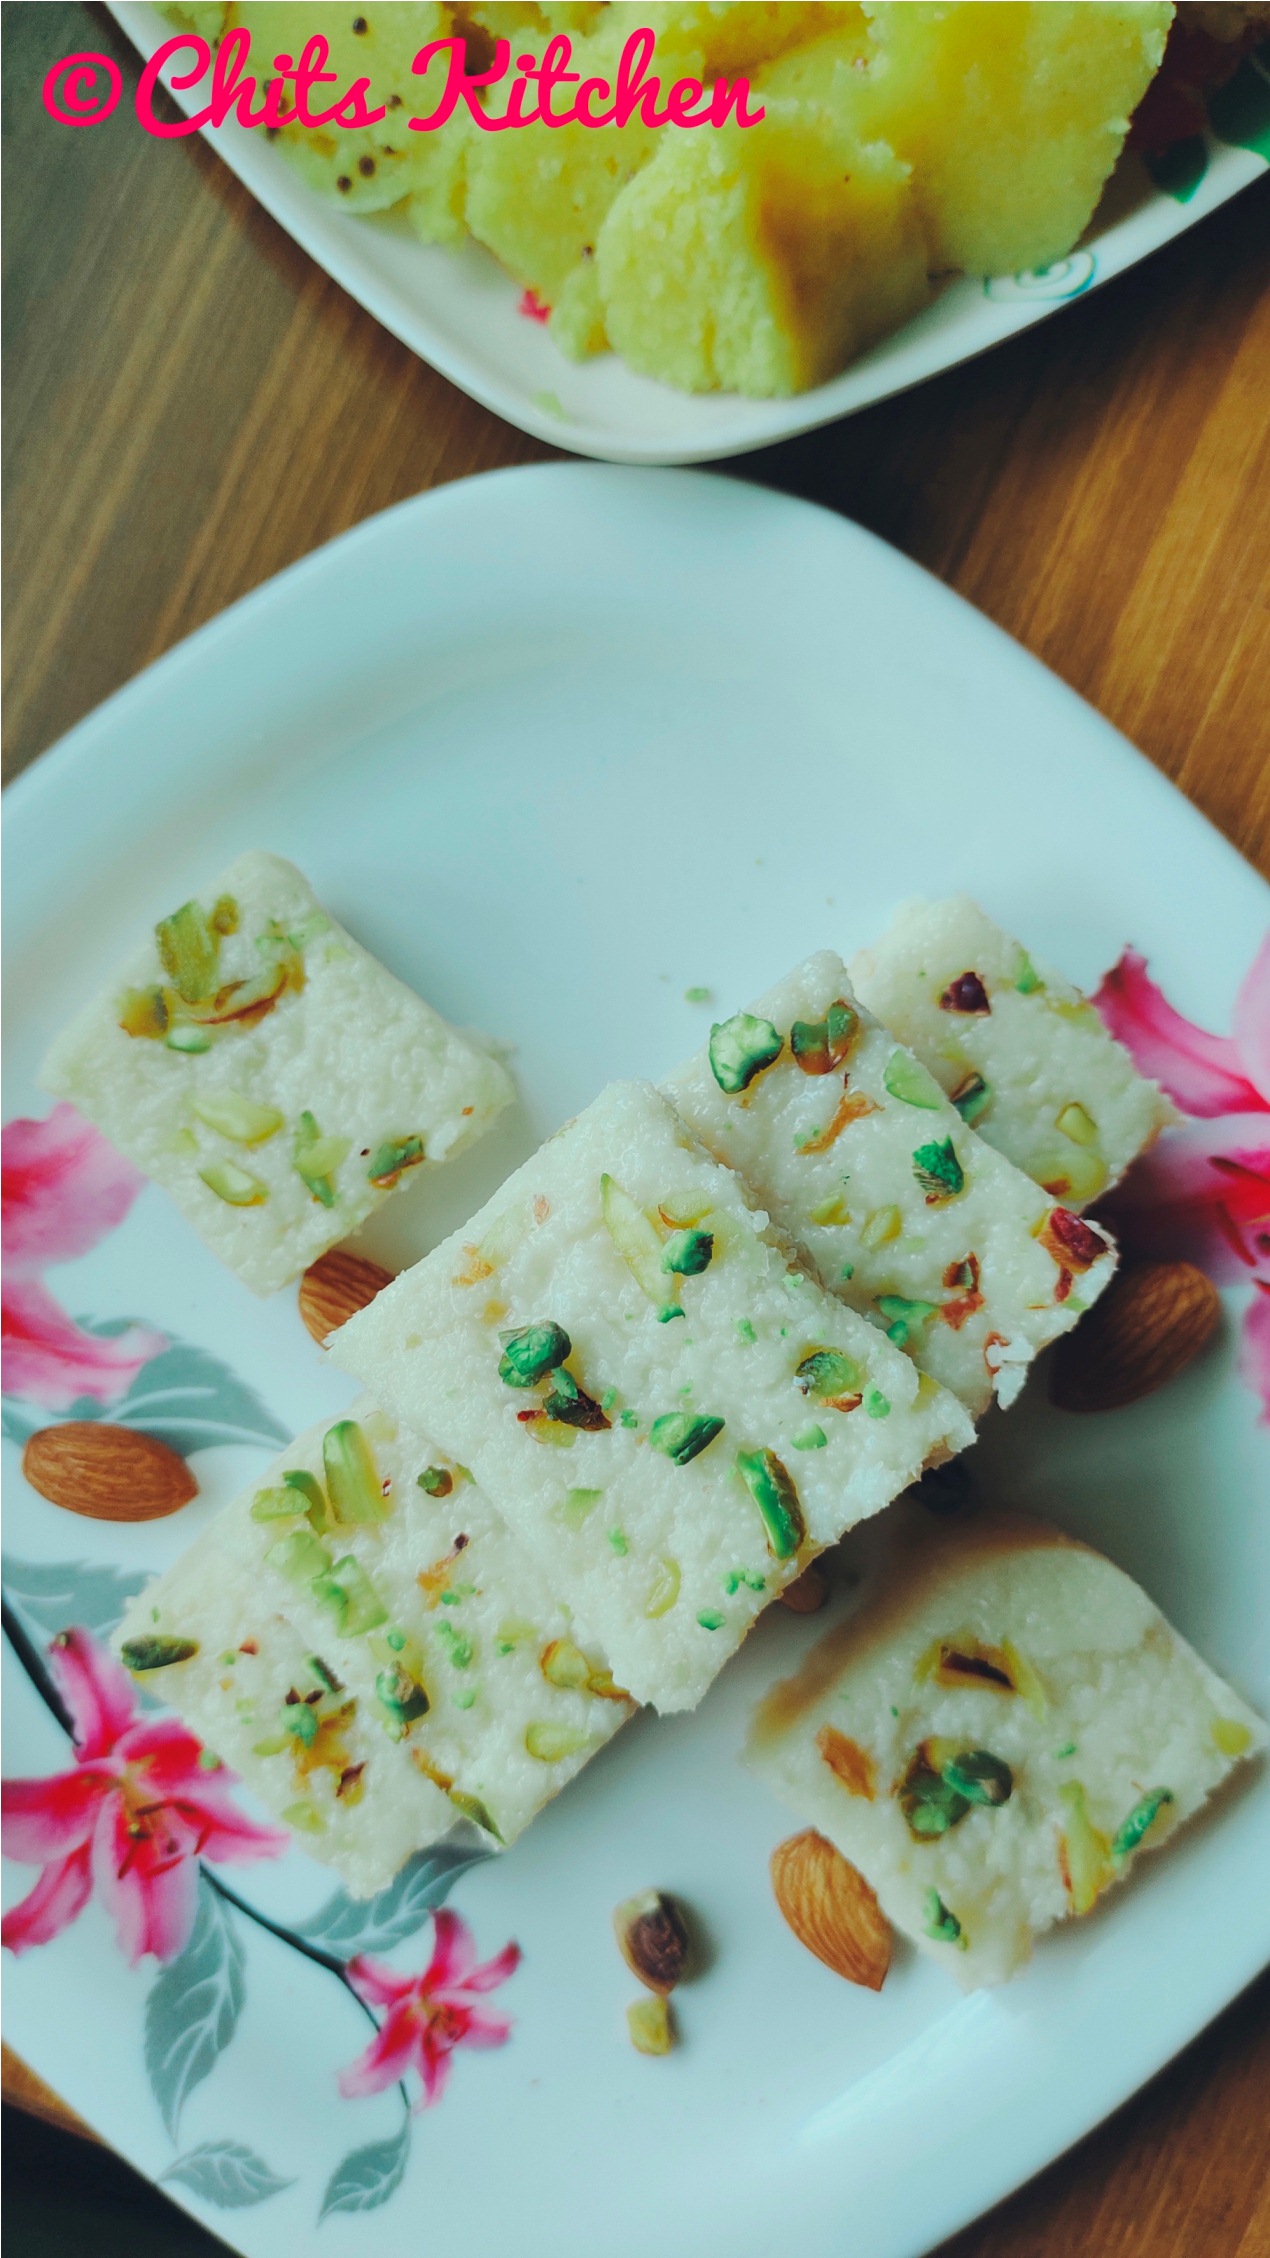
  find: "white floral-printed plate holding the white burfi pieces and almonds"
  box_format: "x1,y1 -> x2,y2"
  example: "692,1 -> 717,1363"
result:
7,465 -> 1270,2258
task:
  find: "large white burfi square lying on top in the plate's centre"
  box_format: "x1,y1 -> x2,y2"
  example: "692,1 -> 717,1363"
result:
330,1082 -> 974,1709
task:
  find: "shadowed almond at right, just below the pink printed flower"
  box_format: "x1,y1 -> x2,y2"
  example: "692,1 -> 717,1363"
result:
1049,1262 -> 1220,1411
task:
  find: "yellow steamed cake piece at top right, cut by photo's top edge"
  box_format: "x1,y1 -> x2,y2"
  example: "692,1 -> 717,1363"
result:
865,0 -> 1173,275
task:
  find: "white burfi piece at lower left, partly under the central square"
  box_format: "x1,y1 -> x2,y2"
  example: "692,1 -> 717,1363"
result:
197,1400 -> 633,1843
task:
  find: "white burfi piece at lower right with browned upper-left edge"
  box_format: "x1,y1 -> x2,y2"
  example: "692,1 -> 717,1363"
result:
748,1502 -> 1268,1989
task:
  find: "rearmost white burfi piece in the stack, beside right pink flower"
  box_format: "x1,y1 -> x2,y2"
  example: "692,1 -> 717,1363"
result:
852,894 -> 1177,1208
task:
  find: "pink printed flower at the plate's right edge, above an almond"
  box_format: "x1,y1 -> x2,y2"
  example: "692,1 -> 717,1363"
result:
1094,937 -> 1270,1425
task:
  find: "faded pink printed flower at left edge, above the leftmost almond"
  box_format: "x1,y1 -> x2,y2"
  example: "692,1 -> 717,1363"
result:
0,1104 -> 167,1411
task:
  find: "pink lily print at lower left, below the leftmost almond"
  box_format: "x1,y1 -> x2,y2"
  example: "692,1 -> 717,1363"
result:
0,1630 -> 289,1967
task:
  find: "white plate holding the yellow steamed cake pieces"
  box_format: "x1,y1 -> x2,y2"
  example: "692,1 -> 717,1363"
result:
111,0 -> 1270,463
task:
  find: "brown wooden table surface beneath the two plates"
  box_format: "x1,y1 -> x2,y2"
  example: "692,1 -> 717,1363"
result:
2,0 -> 1270,2258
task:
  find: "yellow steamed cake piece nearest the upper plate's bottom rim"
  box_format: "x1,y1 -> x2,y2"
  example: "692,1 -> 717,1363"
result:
597,34 -> 929,397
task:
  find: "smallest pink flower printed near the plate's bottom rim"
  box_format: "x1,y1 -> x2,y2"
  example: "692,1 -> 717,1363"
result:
339,1908 -> 520,2109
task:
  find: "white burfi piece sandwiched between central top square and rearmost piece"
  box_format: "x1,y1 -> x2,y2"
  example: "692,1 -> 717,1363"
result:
662,951 -> 1116,1418
